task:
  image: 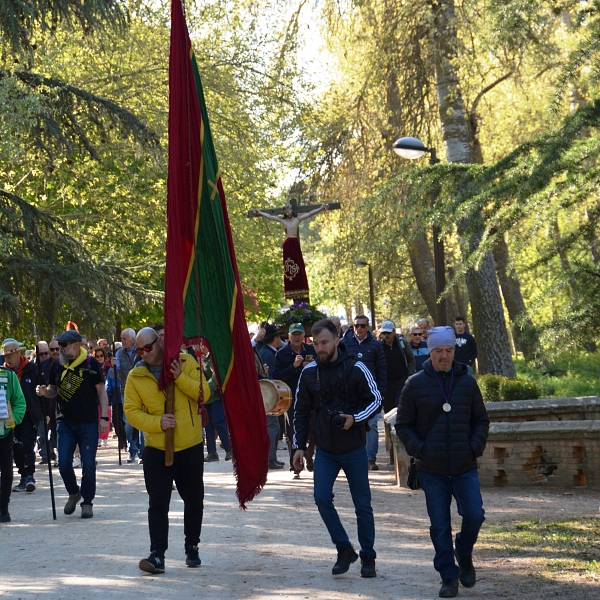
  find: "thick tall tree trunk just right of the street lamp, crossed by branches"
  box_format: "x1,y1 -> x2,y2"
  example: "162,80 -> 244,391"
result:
432,0 -> 515,377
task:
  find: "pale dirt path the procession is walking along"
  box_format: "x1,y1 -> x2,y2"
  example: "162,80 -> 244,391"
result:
0,442 -> 600,600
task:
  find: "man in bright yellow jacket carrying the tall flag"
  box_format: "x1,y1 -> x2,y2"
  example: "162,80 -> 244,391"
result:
124,327 -> 210,573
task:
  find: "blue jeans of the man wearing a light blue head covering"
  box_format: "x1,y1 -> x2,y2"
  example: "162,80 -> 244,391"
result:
419,469 -> 485,579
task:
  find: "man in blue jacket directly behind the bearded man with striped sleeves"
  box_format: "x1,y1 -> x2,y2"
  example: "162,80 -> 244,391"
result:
342,315 -> 387,471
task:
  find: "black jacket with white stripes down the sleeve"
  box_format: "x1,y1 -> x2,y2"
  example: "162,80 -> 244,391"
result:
294,347 -> 381,454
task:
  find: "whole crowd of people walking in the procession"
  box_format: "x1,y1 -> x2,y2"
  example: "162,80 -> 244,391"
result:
0,315 -> 489,597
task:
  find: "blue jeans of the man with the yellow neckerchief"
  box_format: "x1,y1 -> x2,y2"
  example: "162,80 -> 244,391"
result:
56,421 -> 98,506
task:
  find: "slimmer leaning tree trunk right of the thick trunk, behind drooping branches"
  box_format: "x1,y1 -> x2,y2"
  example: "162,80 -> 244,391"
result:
494,234 -> 539,361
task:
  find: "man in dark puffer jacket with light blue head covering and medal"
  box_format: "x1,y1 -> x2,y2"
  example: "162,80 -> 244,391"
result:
396,327 -> 490,598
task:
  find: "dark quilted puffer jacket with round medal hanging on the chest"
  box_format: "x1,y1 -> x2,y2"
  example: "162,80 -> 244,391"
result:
396,359 -> 490,477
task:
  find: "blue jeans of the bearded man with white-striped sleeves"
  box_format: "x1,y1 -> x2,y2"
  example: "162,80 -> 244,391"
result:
314,446 -> 376,558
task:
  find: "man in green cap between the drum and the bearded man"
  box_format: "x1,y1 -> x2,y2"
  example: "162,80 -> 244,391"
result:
273,323 -> 315,479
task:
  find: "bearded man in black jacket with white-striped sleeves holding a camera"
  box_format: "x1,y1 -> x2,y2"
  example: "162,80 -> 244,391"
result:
293,319 -> 381,577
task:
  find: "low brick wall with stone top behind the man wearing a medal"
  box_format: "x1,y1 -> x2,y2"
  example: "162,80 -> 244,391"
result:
385,396 -> 600,487
